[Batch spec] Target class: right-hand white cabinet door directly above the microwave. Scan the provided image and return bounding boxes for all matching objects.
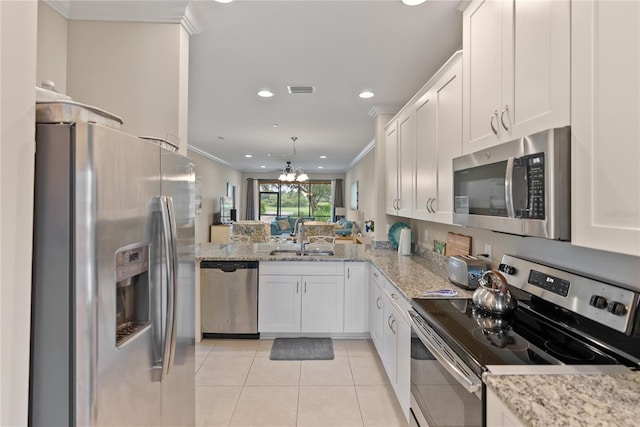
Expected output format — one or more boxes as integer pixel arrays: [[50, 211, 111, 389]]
[[510, 0, 571, 140]]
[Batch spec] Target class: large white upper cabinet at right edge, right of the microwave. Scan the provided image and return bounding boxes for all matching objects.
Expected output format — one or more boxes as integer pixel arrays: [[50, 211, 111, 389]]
[[571, 1, 640, 256]]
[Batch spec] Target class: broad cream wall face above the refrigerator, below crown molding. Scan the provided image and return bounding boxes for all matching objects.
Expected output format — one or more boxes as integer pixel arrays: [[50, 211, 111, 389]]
[[67, 21, 189, 155]]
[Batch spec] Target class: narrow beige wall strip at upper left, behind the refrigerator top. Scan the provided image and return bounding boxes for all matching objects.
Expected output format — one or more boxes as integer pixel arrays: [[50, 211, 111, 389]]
[[35, 1, 67, 93]]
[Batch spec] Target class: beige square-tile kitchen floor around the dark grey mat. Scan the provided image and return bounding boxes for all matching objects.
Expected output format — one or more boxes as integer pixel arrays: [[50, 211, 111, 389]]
[[196, 339, 407, 427]]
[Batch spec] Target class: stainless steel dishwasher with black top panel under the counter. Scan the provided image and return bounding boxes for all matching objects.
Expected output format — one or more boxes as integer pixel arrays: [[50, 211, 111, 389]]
[[200, 261, 260, 338]]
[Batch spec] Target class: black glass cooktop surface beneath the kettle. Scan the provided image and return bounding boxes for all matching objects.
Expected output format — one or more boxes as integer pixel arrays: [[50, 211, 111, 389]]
[[412, 299, 619, 367]]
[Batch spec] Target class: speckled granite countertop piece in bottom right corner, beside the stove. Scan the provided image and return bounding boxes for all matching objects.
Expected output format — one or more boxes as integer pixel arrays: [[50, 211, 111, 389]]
[[484, 371, 640, 427]]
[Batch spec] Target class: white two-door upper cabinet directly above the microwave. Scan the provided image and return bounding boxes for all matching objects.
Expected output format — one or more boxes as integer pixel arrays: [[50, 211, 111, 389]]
[[462, 0, 570, 154]]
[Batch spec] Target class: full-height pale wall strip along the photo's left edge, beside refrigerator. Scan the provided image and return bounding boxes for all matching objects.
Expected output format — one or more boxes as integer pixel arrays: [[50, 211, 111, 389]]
[[0, 1, 38, 426]]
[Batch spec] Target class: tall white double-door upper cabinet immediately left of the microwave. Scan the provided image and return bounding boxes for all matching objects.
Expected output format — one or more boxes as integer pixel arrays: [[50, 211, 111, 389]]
[[412, 52, 462, 224]]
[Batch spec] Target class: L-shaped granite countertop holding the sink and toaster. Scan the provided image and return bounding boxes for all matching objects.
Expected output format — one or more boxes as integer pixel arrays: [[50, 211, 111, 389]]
[[196, 243, 473, 299]]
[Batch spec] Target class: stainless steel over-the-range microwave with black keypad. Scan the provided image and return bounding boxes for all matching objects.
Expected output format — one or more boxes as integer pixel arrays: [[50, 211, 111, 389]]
[[453, 126, 571, 240]]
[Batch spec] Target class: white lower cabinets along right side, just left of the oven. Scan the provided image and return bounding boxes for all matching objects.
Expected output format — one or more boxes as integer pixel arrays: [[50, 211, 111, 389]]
[[369, 267, 411, 421]]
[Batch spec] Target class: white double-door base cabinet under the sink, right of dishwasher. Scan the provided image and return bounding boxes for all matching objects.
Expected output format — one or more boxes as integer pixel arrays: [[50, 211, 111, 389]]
[[258, 262, 344, 333]]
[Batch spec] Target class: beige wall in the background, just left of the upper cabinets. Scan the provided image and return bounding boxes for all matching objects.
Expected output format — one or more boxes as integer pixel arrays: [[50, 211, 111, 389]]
[[344, 147, 376, 233]]
